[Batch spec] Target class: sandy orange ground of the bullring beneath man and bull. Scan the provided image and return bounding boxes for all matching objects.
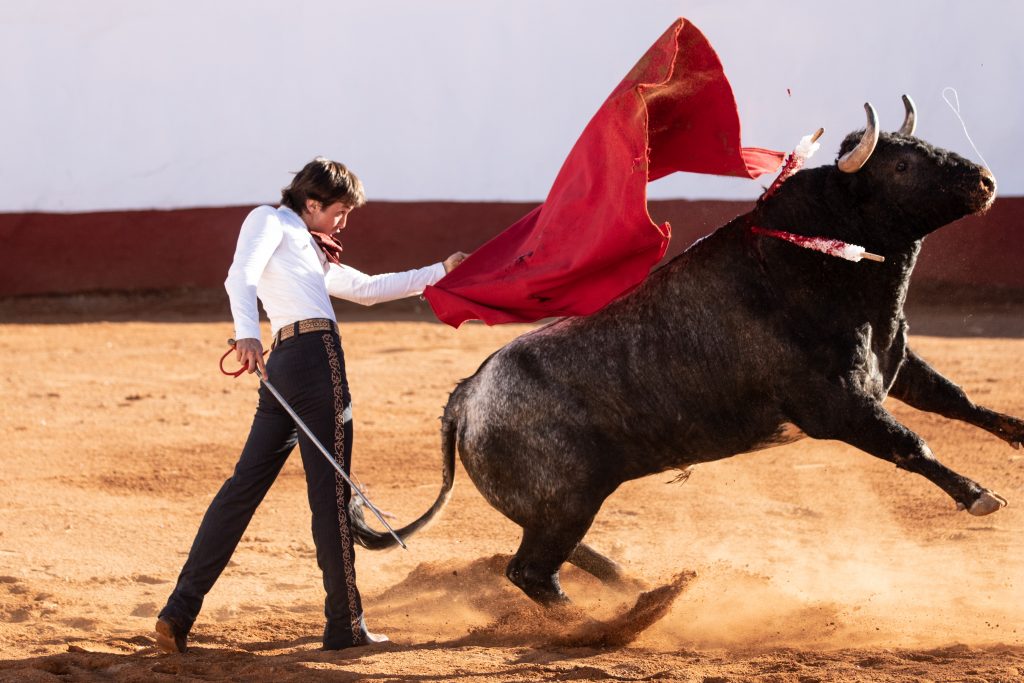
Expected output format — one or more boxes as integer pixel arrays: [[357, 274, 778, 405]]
[[0, 301, 1024, 683]]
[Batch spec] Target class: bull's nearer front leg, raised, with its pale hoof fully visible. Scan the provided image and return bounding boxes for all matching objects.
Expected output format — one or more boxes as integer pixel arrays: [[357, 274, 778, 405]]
[[790, 393, 1007, 516]]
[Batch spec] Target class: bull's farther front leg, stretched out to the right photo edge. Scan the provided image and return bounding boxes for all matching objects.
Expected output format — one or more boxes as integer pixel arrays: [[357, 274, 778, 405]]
[[889, 349, 1024, 449]]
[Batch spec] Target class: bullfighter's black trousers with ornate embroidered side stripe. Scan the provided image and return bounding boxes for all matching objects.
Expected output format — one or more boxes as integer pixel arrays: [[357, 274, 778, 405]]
[[160, 332, 366, 648]]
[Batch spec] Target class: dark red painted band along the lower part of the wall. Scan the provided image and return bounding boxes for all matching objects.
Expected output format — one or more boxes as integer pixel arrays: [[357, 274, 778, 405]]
[[0, 197, 1024, 296]]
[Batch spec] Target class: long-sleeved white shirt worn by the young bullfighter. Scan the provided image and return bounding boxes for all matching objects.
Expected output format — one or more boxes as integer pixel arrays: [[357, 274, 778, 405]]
[[224, 206, 444, 339]]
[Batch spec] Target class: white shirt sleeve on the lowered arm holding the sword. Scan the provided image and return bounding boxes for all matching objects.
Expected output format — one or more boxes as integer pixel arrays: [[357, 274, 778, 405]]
[[224, 206, 284, 339]]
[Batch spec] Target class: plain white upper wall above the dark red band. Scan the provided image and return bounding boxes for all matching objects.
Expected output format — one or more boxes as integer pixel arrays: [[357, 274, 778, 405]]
[[0, 0, 1024, 212]]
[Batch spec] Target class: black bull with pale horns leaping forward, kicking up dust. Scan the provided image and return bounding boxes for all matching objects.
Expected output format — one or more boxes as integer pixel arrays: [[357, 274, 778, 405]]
[[353, 104, 1024, 603]]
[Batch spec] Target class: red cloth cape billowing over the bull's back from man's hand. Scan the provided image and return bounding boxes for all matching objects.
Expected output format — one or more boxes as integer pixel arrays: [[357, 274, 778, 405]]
[[424, 18, 783, 327]]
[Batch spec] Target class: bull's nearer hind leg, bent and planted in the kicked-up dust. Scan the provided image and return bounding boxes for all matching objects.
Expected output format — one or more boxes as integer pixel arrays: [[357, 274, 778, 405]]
[[505, 515, 594, 606]]
